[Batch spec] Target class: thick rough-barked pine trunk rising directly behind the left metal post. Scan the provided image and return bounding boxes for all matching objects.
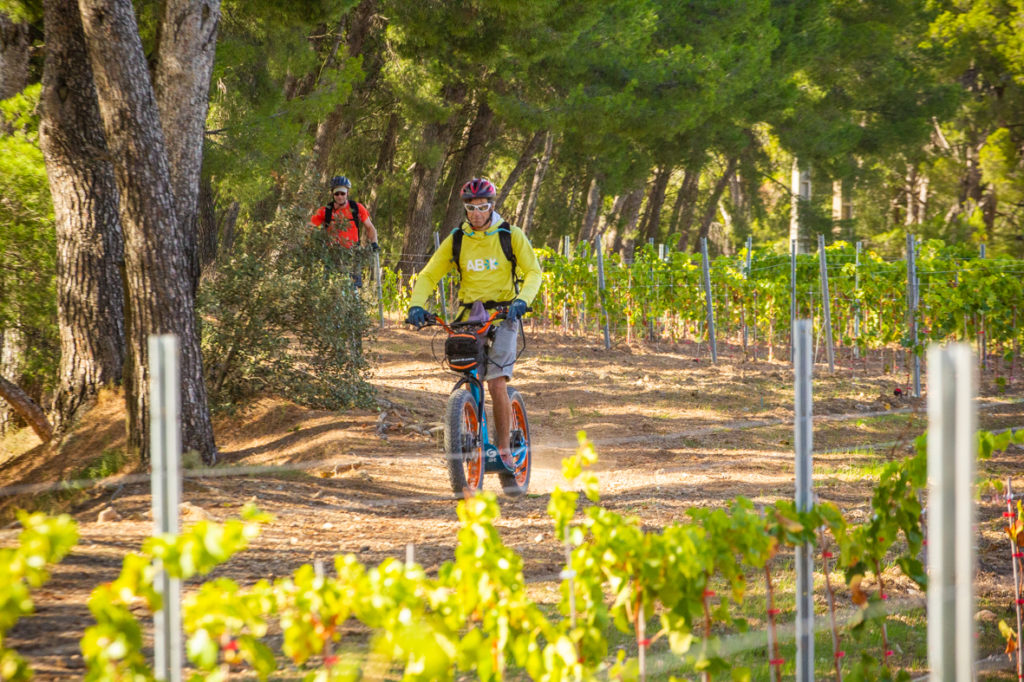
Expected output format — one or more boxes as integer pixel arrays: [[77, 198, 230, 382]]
[[79, 0, 216, 464]]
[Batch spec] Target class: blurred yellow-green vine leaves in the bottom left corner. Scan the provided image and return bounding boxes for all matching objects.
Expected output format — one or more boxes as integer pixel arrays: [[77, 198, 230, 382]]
[[0, 511, 78, 682]]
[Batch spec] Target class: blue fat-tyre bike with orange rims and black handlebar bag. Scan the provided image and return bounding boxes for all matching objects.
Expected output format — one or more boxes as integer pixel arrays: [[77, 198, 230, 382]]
[[409, 306, 532, 496]]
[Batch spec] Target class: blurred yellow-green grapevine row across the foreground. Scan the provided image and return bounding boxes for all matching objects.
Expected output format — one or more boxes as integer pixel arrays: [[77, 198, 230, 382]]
[[0, 432, 1024, 680]]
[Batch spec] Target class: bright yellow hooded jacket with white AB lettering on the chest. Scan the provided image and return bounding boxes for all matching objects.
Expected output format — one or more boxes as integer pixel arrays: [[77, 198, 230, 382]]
[[410, 213, 542, 315]]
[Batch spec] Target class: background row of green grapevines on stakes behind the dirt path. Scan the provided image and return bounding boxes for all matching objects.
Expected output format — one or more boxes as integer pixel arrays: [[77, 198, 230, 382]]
[[385, 240, 1024, 353]]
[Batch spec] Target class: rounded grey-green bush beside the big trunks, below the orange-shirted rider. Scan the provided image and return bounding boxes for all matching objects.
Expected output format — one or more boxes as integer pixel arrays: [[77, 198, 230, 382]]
[[198, 206, 372, 410]]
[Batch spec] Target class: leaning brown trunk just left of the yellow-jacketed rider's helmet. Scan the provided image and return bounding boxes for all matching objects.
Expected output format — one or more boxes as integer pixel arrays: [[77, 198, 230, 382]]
[[399, 84, 466, 275]]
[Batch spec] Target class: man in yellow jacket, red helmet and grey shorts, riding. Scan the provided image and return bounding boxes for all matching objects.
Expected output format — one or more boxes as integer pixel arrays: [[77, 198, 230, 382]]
[[406, 178, 542, 457]]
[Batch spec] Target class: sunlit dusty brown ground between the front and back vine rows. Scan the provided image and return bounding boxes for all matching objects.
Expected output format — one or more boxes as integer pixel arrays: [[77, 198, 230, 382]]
[[0, 329, 1024, 679]]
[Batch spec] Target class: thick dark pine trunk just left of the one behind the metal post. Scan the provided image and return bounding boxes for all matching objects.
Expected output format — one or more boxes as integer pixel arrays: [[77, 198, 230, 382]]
[[39, 0, 125, 433]]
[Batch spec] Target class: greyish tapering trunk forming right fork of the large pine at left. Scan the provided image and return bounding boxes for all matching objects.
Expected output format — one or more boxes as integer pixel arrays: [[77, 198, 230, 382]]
[[154, 0, 220, 297]]
